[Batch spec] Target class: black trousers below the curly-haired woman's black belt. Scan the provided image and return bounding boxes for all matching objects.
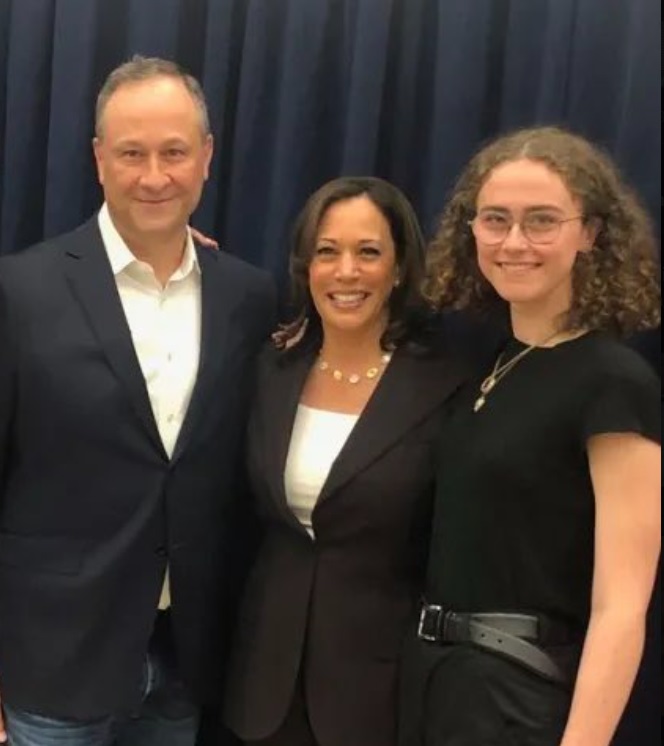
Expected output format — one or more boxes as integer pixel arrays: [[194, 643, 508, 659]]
[[399, 640, 571, 746]]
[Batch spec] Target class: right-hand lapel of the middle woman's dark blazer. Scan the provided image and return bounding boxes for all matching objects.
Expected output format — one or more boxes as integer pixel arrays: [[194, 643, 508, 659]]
[[318, 351, 465, 504]]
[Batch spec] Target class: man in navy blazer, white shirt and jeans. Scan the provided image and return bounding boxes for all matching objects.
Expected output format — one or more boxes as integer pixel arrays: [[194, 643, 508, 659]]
[[0, 58, 273, 746]]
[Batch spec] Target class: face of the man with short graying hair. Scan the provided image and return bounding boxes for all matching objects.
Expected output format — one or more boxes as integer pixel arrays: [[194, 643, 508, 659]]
[[94, 77, 212, 248]]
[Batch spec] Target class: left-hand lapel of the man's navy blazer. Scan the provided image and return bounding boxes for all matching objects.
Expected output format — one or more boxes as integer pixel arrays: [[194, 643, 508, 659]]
[[65, 217, 166, 457]]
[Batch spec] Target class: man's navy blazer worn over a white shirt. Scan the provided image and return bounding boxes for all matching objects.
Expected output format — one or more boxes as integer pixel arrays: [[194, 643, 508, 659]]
[[0, 219, 273, 718]]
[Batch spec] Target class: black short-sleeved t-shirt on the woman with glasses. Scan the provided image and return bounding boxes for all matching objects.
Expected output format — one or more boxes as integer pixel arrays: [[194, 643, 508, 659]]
[[426, 332, 661, 628]]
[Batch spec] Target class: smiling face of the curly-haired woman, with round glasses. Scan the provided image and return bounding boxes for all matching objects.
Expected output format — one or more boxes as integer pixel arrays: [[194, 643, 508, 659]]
[[473, 158, 595, 317]]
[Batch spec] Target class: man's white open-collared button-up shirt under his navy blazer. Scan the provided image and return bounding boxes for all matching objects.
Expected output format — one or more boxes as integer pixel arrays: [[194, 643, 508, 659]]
[[99, 204, 201, 609]]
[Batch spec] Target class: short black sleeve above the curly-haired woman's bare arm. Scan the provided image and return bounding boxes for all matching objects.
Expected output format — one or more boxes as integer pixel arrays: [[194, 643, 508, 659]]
[[581, 361, 662, 443]]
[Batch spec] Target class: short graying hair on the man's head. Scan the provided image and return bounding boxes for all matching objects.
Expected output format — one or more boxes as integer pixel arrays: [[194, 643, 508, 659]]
[[95, 55, 210, 137]]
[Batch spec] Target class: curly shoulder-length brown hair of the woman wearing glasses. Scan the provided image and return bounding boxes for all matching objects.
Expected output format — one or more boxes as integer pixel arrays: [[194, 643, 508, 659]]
[[424, 127, 661, 334]]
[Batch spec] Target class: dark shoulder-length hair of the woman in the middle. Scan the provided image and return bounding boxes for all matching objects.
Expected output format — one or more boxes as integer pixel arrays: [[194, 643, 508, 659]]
[[275, 176, 426, 349]]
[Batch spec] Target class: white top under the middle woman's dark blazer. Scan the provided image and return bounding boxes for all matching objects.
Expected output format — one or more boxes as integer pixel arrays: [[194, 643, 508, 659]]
[[284, 404, 359, 537]]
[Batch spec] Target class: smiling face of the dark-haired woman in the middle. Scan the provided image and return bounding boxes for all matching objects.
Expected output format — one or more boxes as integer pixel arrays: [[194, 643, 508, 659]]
[[309, 195, 397, 339]]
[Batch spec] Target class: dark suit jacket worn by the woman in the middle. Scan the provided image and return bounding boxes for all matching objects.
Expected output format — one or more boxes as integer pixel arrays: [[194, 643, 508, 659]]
[[226, 342, 462, 746]]
